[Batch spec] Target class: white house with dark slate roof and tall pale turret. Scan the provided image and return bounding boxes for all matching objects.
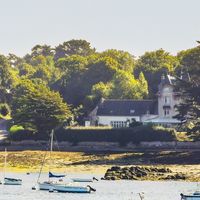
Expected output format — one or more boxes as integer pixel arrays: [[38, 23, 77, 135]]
[[85, 75, 181, 128]]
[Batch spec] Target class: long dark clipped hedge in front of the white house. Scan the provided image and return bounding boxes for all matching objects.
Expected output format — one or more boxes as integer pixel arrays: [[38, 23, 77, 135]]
[[11, 125, 175, 145]]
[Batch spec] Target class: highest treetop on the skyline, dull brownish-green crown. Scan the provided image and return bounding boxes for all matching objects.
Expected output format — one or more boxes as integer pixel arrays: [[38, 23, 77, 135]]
[[54, 40, 95, 61]]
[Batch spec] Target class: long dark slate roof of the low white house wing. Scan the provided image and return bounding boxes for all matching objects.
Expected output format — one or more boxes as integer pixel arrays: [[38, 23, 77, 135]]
[[97, 99, 158, 116]]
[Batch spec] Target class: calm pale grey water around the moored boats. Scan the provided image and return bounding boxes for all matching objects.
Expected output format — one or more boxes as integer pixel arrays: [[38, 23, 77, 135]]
[[0, 173, 200, 200]]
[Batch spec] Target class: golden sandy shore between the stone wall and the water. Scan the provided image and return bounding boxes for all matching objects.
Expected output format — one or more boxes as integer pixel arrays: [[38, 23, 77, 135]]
[[0, 151, 200, 181]]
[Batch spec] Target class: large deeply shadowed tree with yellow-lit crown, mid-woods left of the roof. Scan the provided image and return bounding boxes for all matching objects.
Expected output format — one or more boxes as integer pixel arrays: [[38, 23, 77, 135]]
[[58, 55, 117, 107]]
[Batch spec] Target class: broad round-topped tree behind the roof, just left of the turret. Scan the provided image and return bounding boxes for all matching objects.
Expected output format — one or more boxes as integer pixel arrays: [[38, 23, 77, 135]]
[[134, 49, 178, 97]]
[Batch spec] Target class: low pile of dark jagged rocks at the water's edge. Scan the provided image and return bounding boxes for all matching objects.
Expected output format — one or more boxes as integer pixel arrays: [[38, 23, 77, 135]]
[[103, 166, 188, 180]]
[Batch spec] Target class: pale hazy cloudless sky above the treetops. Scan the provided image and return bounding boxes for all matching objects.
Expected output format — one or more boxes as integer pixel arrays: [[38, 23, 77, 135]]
[[0, 0, 200, 56]]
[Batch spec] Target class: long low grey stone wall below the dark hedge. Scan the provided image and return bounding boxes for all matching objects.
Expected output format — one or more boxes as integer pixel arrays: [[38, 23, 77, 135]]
[[0, 140, 200, 151]]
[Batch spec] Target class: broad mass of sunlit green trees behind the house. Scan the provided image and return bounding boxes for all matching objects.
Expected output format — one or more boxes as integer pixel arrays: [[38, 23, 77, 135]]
[[0, 40, 200, 138]]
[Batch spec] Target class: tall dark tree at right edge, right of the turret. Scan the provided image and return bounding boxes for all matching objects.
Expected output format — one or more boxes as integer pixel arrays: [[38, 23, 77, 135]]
[[176, 46, 200, 140]]
